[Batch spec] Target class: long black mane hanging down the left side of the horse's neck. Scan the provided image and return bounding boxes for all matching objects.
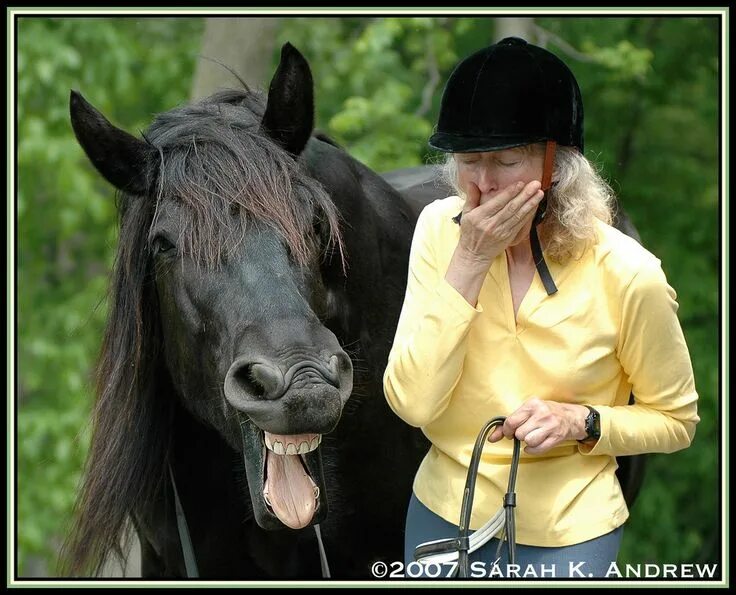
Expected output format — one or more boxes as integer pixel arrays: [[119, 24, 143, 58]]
[[59, 191, 173, 576]]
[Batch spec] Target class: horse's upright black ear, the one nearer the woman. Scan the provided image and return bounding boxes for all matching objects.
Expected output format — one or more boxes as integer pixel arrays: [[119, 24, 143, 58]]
[[261, 42, 314, 157]]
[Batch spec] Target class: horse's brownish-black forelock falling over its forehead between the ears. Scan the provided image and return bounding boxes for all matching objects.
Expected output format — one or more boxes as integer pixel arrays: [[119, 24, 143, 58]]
[[146, 91, 342, 266]]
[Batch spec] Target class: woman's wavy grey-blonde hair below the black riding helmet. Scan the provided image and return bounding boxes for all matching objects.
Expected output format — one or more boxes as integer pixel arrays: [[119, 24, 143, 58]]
[[440, 144, 616, 264]]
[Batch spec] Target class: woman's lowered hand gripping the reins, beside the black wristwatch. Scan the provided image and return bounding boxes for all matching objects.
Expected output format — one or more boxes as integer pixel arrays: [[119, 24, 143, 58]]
[[488, 397, 588, 454]]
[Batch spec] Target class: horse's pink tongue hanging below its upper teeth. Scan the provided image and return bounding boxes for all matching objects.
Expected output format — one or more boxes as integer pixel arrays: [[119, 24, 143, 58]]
[[263, 450, 317, 529]]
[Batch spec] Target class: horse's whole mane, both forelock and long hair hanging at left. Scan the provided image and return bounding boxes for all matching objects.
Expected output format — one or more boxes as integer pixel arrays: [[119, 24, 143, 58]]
[[59, 86, 342, 576]]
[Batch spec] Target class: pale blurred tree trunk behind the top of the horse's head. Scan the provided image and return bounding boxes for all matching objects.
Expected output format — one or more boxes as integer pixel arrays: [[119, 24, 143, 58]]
[[192, 17, 279, 100]]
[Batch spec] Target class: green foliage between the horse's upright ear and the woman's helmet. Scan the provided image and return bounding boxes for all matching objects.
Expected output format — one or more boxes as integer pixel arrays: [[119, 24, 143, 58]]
[[278, 18, 490, 171]]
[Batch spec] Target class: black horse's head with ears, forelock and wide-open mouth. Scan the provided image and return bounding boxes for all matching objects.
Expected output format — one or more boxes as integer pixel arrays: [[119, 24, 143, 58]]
[[71, 44, 353, 528]]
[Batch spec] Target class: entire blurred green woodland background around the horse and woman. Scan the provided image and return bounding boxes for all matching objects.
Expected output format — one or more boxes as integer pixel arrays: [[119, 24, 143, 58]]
[[16, 14, 721, 577]]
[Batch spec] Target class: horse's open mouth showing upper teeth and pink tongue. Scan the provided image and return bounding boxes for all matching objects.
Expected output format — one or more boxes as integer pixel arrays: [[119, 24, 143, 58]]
[[263, 432, 322, 529]]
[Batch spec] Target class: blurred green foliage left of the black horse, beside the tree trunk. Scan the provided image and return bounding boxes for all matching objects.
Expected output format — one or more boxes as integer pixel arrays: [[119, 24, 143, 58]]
[[17, 17, 202, 576]]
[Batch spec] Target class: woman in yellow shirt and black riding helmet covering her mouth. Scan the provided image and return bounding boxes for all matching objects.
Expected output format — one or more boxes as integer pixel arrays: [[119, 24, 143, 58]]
[[384, 38, 699, 578]]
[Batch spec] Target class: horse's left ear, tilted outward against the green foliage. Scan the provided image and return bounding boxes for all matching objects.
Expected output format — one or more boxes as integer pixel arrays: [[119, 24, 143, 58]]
[[69, 90, 156, 195]]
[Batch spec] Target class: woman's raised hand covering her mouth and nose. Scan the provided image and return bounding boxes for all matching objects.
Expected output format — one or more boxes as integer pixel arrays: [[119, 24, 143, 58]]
[[457, 180, 544, 267]]
